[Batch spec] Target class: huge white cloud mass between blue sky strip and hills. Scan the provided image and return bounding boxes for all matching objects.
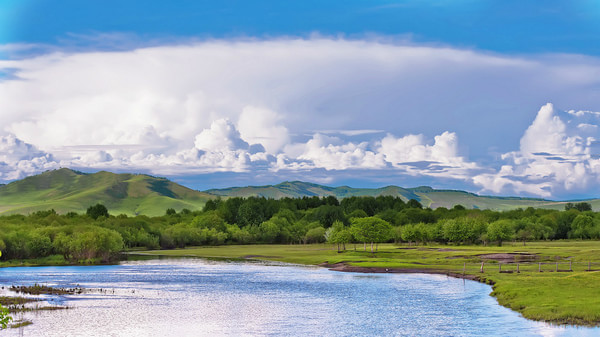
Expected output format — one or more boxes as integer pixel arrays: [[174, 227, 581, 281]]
[[0, 38, 600, 196]]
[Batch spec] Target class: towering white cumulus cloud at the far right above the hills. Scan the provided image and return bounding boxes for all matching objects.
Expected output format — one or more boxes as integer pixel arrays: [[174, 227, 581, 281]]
[[474, 103, 600, 197]]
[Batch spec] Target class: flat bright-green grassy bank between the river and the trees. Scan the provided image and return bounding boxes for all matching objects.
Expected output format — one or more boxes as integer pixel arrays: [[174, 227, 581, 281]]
[[138, 241, 600, 325]]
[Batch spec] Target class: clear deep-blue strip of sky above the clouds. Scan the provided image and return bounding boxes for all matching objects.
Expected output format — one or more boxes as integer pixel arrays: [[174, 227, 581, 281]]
[[0, 0, 600, 55]]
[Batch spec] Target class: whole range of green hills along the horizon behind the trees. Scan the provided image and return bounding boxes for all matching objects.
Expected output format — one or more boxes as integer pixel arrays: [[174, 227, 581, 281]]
[[0, 168, 600, 216]]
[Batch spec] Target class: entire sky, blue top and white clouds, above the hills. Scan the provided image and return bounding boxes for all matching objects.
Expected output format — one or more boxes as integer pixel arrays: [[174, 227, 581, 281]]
[[0, 0, 600, 200]]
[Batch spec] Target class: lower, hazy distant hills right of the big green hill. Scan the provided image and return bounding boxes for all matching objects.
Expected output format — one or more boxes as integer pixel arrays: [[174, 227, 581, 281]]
[[205, 181, 600, 210]]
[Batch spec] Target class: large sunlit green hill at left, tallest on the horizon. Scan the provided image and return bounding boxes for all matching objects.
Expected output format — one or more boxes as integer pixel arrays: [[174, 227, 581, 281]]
[[0, 168, 214, 216]]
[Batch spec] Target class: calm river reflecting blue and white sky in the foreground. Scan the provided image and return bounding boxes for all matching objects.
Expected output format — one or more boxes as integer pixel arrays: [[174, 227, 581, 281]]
[[0, 259, 600, 336]]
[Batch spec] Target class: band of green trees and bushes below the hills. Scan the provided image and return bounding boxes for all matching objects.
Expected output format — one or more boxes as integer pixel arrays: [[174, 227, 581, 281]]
[[0, 196, 600, 262]]
